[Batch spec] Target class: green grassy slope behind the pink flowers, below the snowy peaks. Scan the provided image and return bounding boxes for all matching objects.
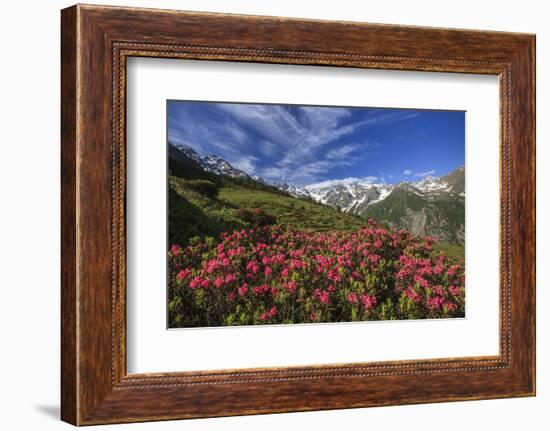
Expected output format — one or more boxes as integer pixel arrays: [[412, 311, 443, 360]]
[[168, 177, 366, 244]]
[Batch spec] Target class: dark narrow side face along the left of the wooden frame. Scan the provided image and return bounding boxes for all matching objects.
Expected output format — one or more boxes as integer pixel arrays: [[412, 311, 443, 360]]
[[60, 6, 79, 425]]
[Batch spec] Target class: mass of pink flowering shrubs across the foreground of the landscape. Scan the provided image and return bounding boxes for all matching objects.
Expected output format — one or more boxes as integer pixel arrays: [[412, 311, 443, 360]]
[[168, 221, 464, 327]]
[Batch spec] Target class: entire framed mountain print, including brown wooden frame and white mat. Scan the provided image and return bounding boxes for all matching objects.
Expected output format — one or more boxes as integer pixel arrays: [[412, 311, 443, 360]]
[[61, 5, 535, 425]]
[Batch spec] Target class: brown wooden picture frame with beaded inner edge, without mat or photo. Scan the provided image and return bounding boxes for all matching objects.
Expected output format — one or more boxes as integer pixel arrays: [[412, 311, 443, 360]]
[[61, 5, 535, 425]]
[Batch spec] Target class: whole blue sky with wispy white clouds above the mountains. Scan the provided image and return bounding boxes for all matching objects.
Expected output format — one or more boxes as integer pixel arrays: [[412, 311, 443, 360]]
[[168, 100, 465, 186]]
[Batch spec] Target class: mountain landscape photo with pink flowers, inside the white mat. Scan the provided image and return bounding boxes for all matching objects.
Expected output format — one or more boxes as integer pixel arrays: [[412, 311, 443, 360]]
[[167, 100, 466, 328]]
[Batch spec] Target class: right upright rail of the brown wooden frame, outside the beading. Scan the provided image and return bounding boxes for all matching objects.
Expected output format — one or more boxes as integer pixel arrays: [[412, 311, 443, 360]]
[[511, 35, 536, 396]]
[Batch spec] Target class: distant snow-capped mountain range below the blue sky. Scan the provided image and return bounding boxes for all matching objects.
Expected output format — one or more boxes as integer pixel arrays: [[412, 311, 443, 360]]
[[169, 145, 465, 244]]
